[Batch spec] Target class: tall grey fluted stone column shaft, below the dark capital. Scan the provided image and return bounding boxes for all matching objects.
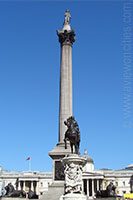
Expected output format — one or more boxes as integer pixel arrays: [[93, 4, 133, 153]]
[[59, 44, 72, 143]]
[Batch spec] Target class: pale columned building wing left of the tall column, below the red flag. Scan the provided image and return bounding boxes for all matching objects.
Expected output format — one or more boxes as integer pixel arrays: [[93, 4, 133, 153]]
[[0, 167, 52, 196]]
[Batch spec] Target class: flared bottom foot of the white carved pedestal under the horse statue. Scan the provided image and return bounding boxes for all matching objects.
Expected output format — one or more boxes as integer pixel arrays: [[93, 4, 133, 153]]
[[59, 193, 87, 200]]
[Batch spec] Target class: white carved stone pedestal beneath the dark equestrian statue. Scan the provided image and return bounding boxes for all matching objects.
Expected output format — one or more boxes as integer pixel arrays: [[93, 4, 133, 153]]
[[60, 154, 87, 200]]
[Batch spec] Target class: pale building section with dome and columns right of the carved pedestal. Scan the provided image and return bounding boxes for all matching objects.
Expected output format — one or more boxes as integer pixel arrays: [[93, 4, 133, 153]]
[[83, 151, 133, 199]]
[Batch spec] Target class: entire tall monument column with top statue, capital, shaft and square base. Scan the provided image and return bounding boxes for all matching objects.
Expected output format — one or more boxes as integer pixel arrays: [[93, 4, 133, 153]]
[[49, 10, 75, 181]]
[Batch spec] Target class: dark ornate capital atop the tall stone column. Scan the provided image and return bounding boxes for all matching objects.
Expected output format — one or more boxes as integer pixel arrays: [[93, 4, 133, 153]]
[[57, 30, 76, 46]]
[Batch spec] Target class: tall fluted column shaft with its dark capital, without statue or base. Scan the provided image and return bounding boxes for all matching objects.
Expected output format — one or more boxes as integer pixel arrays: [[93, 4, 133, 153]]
[[57, 25, 75, 144]]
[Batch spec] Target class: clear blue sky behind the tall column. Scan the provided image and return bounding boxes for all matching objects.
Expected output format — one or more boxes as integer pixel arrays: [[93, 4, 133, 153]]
[[0, 1, 133, 171]]
